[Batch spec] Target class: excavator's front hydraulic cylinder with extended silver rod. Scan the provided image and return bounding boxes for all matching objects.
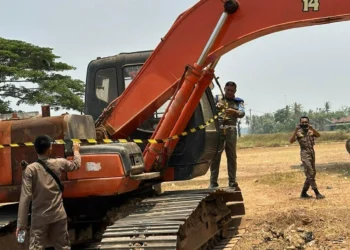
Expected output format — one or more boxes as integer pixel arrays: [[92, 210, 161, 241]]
[[144, 0, 238, 172]]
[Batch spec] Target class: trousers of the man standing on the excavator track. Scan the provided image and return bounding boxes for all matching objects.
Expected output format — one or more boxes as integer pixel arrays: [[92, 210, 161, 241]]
[[210, 128, 237, 183]]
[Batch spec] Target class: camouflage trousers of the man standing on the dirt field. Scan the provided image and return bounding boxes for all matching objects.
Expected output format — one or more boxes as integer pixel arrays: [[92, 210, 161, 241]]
[[300, 151, 317, 189]]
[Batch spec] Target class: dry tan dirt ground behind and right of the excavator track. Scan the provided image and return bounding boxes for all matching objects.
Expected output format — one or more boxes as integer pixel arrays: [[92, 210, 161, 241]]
[[165, 142, 350, 249]]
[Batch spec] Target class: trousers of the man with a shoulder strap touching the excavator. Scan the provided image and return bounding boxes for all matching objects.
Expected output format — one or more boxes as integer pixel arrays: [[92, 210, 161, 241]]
[[29, 219, 71, 250]]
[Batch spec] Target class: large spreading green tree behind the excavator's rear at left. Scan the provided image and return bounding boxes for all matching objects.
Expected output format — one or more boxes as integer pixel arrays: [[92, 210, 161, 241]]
[[0, 37, 84, 114]]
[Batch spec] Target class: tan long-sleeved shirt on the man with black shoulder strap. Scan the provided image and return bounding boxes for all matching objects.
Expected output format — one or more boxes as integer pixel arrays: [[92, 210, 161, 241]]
[[17, 152, 81, 228]]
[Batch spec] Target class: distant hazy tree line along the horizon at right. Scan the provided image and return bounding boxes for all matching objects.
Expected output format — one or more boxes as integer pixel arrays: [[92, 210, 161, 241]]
[[245, 102, 350, 134]]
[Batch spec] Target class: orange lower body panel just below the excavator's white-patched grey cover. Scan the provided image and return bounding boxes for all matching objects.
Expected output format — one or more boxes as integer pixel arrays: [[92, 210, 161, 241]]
[[63, 177, 123, 198]]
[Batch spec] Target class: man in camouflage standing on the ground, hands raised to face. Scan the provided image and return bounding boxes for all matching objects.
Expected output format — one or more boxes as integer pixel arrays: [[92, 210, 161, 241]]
[[289, 116, 325, 199]]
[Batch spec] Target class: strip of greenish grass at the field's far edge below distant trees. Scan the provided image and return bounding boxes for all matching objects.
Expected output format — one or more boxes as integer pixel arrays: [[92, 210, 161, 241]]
[[237, 131, 350, 148]]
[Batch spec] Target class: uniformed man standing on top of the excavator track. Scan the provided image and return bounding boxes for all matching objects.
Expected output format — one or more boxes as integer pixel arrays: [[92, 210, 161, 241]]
[[209, 81, 245, 188]]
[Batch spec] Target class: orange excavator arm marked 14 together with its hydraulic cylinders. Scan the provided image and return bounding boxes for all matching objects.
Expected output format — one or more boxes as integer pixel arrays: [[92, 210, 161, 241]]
[[98, 0, 350, 171]]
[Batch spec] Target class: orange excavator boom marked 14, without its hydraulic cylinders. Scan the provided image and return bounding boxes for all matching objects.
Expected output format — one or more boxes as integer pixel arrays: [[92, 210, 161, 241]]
[[102, 0, 350, 139]]
